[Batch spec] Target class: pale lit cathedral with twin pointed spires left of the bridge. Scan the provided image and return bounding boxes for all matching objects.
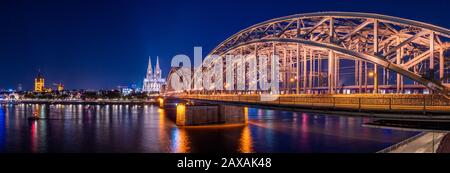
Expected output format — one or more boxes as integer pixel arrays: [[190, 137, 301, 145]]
[[142, 57, 166, 93]]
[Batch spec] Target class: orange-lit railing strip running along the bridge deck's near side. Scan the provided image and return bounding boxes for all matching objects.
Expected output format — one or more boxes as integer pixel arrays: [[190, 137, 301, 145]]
[[180, 94, 450, 112]]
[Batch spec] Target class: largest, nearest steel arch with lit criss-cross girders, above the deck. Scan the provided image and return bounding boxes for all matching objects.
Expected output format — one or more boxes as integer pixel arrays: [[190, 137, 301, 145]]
[[174, 12, 450, 97]]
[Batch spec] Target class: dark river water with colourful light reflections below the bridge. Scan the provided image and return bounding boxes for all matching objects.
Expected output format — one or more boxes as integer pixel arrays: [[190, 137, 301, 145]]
[[0, 104, 416, 153]]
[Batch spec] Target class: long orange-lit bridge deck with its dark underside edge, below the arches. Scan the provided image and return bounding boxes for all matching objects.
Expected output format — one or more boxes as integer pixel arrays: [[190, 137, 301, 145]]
[[177, 94, 450, 117]]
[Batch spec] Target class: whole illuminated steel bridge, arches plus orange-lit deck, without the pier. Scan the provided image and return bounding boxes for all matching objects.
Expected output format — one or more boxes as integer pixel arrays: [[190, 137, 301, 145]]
[[168, 12, 450, 114]]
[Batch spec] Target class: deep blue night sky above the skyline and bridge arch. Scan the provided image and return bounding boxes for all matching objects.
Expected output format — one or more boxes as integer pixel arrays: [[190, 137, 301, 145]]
[[0, 0, 450, 89]]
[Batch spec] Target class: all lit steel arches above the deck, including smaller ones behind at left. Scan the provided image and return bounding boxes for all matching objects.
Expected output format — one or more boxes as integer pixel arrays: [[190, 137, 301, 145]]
[[168, 12, 450, 98]]
